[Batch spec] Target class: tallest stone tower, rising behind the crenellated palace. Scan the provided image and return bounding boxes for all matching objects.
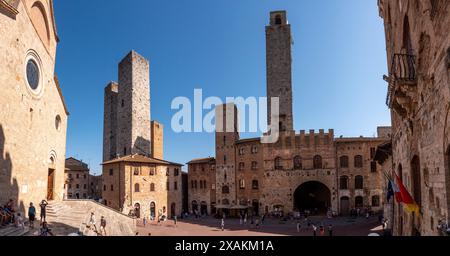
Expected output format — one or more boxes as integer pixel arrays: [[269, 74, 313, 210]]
[[266, 11, 294, 131]]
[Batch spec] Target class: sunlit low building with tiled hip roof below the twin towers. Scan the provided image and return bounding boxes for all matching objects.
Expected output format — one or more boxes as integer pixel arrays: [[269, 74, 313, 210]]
[[102, 155, 182, 218]]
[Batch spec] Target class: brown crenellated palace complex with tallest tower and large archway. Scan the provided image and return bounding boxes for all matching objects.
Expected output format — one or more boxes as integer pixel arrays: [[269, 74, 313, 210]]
[[188, 11, 391, 215]]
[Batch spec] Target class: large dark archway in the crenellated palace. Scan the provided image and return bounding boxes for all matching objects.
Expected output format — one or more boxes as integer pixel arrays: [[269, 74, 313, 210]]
[[294, 181, 331, 214]]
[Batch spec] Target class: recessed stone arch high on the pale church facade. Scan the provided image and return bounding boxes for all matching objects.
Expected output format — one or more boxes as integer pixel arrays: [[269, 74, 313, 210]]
[[30, 1, 50, 47]]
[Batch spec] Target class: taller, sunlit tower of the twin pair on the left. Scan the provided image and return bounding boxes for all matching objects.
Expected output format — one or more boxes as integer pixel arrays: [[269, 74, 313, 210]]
[[117, 51, 151, 156]]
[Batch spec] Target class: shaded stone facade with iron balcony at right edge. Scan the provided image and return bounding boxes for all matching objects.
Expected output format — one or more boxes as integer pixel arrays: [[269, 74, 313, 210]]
[[378, 0, 450, 235]]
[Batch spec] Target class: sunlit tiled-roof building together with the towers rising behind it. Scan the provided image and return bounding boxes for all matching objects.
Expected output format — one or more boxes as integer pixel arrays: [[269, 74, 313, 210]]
[[102, 51, 182, 218]]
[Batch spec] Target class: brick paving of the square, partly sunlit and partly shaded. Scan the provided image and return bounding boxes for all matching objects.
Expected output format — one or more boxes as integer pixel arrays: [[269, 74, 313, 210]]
[[137, 217, 382, 236]]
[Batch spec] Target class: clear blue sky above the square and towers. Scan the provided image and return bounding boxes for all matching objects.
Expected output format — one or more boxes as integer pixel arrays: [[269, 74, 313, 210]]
[[55, 0, 390, 173]]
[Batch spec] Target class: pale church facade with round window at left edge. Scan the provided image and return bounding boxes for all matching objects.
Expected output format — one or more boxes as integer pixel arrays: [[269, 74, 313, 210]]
[[0, 0, 68, 211]]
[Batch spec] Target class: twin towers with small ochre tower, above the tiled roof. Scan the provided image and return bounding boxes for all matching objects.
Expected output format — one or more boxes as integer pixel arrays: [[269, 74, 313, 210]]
[[103, 51, 164, 162]]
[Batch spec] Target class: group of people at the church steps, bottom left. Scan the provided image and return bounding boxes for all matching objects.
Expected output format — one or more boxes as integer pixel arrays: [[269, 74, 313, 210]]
[[0, 199, 53, 236]]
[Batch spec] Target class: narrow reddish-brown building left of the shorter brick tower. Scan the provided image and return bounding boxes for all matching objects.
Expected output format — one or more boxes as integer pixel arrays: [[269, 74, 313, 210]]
[[187, 157, 216, 215]]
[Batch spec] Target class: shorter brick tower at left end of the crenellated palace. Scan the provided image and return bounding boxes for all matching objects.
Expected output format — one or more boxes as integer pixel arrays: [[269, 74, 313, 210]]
[[216, 104, 239, 205]]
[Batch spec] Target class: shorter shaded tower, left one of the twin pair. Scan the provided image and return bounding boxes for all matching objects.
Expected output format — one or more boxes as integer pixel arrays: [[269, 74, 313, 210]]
[[103, 82, 119, 162]]
